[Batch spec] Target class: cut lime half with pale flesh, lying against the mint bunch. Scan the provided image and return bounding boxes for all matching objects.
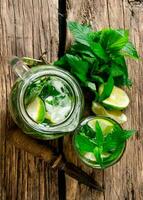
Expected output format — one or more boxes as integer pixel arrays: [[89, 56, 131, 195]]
[[99, 85, 130, 110]]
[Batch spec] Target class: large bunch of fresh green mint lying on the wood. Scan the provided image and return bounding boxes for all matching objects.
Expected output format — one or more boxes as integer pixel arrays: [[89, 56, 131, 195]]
[[54, 22, 139, 100]]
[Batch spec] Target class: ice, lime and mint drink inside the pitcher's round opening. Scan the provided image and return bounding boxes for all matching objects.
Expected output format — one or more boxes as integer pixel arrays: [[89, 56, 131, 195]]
[[24, 76, 74, 126]]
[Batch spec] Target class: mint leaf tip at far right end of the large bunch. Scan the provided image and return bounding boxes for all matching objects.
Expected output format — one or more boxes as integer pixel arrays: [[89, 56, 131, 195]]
[[121, 42, 139, 59]]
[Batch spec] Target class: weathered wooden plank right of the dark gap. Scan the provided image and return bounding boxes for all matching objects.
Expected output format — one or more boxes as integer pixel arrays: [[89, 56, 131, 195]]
[[64, 0, 143, 200]]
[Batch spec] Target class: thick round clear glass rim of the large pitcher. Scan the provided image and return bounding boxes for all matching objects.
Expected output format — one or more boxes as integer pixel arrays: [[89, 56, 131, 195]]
[[18, 65, 83, 134]]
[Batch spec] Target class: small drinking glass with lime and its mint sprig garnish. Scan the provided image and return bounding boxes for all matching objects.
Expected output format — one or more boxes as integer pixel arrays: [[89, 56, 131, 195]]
[[73, 116, 135, 169]]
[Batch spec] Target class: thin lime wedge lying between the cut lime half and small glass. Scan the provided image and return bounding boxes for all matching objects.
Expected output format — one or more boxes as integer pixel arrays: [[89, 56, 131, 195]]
[[92, 101, 127, 124]]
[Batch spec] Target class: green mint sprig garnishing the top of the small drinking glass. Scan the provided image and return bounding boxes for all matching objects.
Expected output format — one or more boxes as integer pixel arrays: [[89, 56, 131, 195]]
[[75, 121, 136, 168]]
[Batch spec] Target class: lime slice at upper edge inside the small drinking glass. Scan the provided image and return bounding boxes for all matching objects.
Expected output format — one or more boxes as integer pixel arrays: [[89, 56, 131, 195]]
[[88, 117, 115, 135]]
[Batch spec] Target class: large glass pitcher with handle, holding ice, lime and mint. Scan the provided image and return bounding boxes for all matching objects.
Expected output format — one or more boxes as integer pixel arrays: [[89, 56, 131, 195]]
[[9, 57, 84, 140]]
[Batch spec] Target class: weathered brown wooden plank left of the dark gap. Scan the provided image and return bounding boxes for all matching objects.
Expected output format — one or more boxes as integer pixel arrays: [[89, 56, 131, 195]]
[[0, 0, 59, 200]]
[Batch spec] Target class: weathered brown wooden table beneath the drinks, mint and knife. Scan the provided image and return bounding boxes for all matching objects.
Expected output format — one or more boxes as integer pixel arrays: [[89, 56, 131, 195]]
[[0, 0, 143, 200]]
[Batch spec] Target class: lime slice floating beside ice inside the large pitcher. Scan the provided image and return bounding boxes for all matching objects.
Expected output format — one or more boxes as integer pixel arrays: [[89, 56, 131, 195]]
[[26, 97, 45, 123]]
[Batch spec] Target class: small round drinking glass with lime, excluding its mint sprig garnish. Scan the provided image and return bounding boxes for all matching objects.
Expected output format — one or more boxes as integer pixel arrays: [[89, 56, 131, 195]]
[[73, 116, 126, 169]]
